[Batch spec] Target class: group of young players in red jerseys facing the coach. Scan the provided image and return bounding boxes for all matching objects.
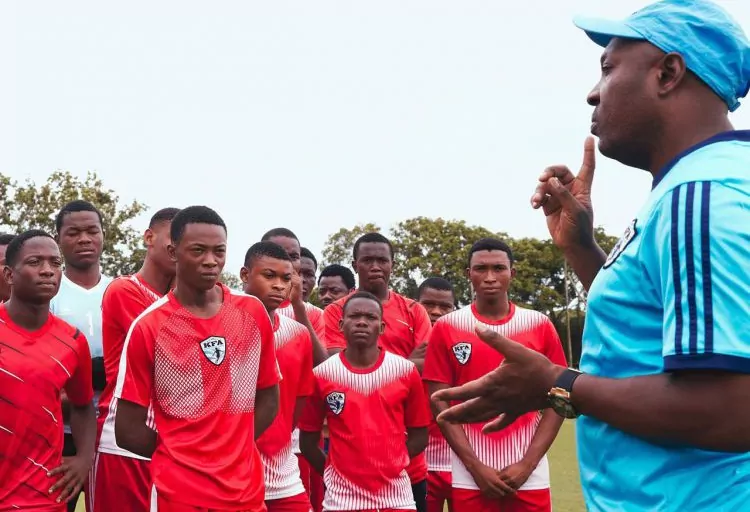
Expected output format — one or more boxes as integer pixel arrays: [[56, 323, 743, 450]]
[[0, 201, 566, 512]]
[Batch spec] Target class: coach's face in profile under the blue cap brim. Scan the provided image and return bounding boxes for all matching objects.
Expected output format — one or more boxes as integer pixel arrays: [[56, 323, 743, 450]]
[[587, 39, 659, 167]]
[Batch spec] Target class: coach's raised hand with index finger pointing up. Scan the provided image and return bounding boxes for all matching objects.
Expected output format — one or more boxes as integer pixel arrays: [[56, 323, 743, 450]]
[[531, 137, 596, 250]]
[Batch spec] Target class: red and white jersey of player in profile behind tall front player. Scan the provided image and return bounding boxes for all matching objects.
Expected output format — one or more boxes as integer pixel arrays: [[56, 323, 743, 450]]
[[97, 274, 161, 460]]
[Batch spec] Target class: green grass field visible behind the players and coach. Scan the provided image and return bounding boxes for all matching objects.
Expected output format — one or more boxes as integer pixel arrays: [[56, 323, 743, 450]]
[[76, 421, 585, 512]]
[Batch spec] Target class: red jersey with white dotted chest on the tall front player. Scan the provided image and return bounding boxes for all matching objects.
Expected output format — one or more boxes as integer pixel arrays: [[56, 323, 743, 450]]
[[115, 285, 281, 510]]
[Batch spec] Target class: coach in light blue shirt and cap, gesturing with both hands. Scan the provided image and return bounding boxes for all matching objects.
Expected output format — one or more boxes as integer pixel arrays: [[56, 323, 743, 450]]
[[439, 0, 750, 512]]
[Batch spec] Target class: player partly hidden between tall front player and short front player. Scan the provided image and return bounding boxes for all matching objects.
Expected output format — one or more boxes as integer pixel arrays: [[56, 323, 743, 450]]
[[245, 242, 313, 512]]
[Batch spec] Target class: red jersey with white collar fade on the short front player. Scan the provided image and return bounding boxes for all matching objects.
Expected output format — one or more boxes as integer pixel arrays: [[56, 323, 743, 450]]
[[300, 350, 430, 510]]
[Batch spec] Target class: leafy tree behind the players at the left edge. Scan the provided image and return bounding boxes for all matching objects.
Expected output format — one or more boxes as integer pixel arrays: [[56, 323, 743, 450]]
[[0, 171, 146, 275]]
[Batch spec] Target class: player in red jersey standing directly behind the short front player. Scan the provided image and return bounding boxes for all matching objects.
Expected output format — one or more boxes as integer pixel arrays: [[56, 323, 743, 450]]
[[323, 233, 431, 512]]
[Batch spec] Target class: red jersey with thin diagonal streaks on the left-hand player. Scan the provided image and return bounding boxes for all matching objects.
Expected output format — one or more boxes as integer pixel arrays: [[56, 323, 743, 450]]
[[0, 305, 94, 512]]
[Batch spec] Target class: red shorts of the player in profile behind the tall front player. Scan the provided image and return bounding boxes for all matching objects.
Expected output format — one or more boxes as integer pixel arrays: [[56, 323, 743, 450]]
[[86, 453, 151, 512]]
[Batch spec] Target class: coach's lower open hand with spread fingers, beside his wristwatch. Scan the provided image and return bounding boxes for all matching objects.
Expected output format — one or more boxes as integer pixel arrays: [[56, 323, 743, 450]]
[[433, 324, 565, 433]]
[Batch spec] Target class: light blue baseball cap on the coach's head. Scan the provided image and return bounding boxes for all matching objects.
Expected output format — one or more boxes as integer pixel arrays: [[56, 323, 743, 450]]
[[573, 0, 750, 112]]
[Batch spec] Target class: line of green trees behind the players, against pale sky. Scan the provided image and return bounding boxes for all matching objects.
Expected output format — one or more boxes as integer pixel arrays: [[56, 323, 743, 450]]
[[0, 171, 617, 363]]
